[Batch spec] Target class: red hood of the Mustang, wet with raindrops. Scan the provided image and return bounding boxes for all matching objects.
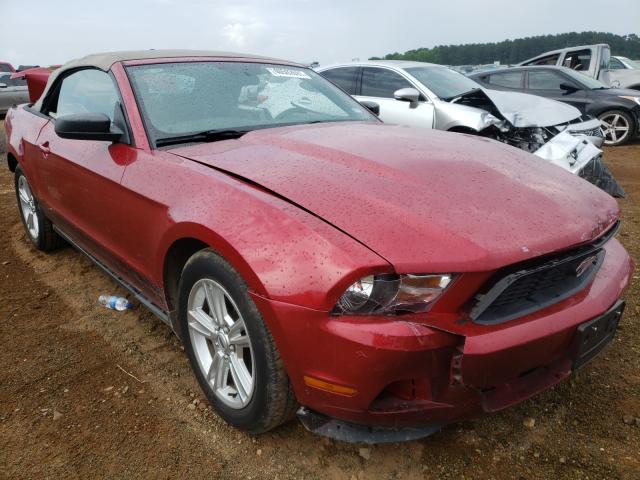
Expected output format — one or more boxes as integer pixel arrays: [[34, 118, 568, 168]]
[[169, 123, 618, 273]]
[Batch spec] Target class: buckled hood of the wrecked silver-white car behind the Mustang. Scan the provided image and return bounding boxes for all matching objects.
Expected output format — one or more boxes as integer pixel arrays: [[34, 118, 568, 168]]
[[459, 88, 581, 128]]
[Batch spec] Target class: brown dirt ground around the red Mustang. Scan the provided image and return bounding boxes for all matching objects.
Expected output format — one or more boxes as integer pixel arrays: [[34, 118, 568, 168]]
[[0, 123, 640, 480]]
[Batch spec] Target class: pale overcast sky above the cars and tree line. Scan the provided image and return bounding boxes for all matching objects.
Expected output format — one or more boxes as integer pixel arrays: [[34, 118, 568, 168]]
[[0, 0, 640, 65]]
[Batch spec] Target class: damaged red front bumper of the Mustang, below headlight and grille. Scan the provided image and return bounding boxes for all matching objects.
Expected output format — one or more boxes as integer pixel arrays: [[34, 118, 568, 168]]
[[252, 240, 633, 442]]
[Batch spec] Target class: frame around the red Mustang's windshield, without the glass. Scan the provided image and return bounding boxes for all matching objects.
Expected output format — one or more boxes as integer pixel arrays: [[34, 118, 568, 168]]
[[123, 57, 381, 149]]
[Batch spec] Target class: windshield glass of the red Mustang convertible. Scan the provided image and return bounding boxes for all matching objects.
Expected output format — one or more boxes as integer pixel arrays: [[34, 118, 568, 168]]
[[127, 61, 377, 141]]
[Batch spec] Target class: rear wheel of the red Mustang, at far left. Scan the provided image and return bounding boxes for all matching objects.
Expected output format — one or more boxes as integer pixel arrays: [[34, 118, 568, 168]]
[[15, 166, 64, 252]]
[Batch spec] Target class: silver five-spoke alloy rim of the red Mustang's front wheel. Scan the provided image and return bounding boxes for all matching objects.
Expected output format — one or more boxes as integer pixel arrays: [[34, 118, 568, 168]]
[[187, 278, 256, 409]]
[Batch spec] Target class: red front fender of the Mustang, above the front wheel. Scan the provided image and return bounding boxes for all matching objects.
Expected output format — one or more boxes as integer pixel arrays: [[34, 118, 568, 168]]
[[142, 153, 393, 311]]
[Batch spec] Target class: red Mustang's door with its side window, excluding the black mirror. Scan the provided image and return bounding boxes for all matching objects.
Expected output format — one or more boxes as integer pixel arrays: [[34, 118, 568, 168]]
[[36, 69, 138, 271]]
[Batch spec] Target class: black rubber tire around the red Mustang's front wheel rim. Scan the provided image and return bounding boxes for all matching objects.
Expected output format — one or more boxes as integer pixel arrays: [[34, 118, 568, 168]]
[[178, 249, 297, 433]]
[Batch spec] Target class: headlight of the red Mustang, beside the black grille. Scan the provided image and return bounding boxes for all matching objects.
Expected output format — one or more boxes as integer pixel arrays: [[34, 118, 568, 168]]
[[333, 274, 453, 315]]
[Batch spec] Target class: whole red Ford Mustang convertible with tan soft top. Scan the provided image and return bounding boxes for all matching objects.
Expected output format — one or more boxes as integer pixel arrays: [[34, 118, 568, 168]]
[[5, 51, 633, 441]]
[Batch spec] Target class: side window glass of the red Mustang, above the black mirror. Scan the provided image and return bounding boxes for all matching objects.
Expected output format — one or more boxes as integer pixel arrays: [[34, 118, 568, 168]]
[[49, 69, 119, 121]]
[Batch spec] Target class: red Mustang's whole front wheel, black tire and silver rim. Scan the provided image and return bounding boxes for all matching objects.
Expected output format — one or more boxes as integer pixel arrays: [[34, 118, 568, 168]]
[[179, 250, 296, 433]]
